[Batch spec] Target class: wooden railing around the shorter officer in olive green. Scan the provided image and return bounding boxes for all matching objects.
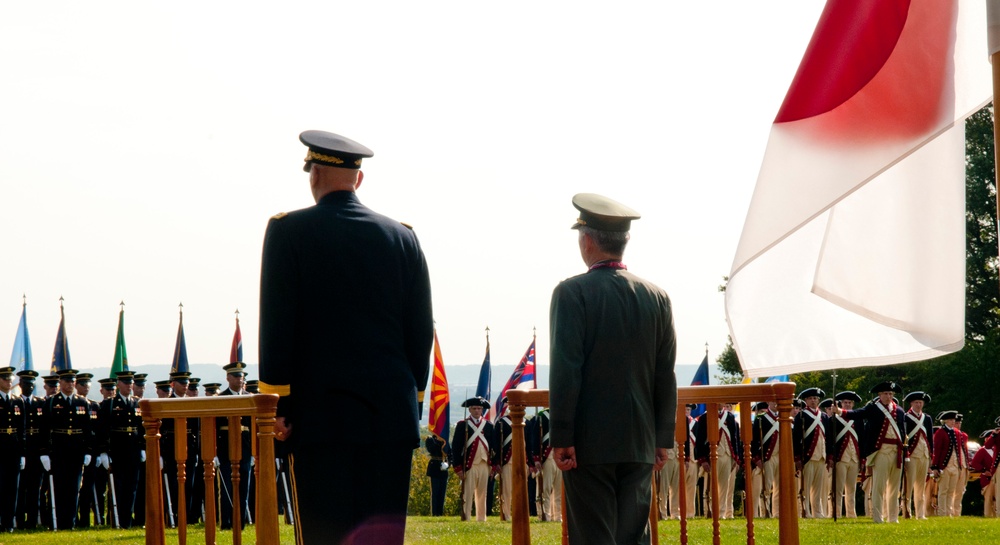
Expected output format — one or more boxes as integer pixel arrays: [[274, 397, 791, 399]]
[[507, 382, 799, 545]]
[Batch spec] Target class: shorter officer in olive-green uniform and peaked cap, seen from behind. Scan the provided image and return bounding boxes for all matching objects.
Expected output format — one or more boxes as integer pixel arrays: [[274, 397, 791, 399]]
[[549, 193, 677, 545]]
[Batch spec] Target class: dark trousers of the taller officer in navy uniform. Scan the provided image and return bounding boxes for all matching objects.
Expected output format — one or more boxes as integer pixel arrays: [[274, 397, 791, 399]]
[[288, 440, 416, 545]]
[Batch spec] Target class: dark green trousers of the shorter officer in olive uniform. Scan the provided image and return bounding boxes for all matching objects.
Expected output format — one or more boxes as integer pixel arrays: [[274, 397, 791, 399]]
[[563, 463, 653, 545]]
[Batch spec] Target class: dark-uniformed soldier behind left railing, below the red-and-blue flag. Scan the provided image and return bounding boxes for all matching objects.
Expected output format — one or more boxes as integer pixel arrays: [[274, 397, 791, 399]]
[[215, 361, 250, 530]]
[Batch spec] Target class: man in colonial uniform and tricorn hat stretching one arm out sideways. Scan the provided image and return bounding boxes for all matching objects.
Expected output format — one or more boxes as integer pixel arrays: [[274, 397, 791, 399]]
[[834, 382, 906, 523]]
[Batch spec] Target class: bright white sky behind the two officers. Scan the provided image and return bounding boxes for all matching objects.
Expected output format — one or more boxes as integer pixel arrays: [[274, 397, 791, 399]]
[[0, 0, 823, 379]]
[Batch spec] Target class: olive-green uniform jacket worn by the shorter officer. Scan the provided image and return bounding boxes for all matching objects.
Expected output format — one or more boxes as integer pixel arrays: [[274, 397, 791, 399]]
[[549, 267, 677, 465]]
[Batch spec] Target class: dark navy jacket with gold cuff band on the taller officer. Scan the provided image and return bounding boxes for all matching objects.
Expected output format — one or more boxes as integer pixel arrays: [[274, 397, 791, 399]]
[[260, 191, 433, 446]]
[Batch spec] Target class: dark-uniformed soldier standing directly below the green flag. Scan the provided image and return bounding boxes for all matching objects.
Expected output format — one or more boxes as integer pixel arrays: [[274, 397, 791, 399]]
[[96, 371, 146, 528]]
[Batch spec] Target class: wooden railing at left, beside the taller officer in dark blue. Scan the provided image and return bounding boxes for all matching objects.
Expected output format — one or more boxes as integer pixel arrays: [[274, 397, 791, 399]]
[[139, 395, 279, 545]]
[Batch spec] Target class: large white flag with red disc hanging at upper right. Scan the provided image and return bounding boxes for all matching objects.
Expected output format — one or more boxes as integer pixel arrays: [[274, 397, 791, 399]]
[[726, 0, 991, 377]]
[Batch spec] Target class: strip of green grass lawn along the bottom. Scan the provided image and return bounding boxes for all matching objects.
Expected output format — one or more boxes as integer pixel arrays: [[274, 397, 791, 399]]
[[0, 517, 1000, 545]]
